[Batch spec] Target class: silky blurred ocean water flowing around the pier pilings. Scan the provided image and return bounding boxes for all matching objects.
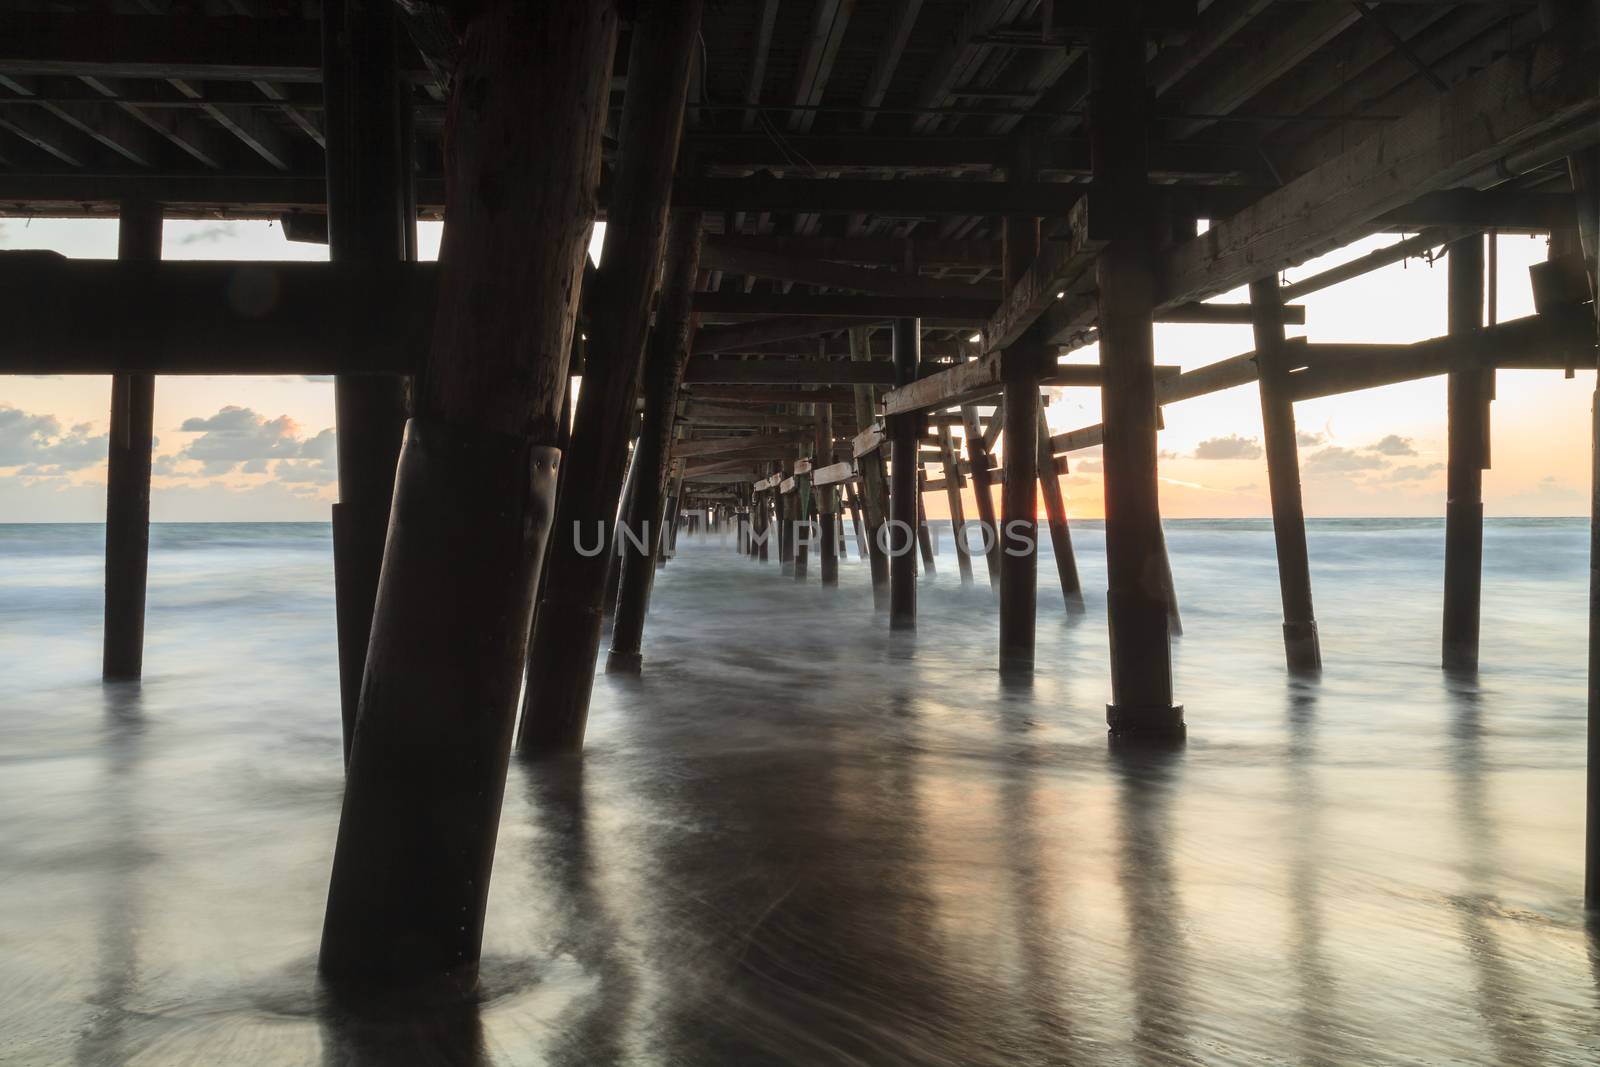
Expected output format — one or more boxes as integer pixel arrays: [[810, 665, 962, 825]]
[[0, 520, 1600, 1065]]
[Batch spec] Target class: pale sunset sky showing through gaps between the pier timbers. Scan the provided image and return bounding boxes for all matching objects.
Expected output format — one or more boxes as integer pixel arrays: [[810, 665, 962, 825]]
[[0, 219, 1594, 523]]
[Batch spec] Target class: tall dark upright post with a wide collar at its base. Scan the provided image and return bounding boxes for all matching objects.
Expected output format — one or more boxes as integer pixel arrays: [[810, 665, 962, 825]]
[[1090, 30, 1184, 737]]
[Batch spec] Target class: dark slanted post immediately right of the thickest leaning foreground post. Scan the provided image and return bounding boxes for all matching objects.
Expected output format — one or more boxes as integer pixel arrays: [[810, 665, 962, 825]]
[[518, 0, 701, 755]]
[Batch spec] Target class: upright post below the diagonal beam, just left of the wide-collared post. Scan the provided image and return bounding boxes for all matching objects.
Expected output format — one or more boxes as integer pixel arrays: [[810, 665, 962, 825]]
[[1000, 344, 1043, 675]]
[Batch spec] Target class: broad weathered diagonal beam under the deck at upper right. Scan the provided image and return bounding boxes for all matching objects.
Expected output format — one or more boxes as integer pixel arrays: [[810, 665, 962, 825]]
[[1157, 40, 1600, 313]]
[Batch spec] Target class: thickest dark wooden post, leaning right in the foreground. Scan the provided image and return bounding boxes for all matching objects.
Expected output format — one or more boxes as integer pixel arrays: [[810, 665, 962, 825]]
[[320, 0, 616, 989]]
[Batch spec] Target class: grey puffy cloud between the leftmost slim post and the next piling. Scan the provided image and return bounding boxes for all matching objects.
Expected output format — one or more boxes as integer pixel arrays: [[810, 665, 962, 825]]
[[172, 405, 338, 485]]
